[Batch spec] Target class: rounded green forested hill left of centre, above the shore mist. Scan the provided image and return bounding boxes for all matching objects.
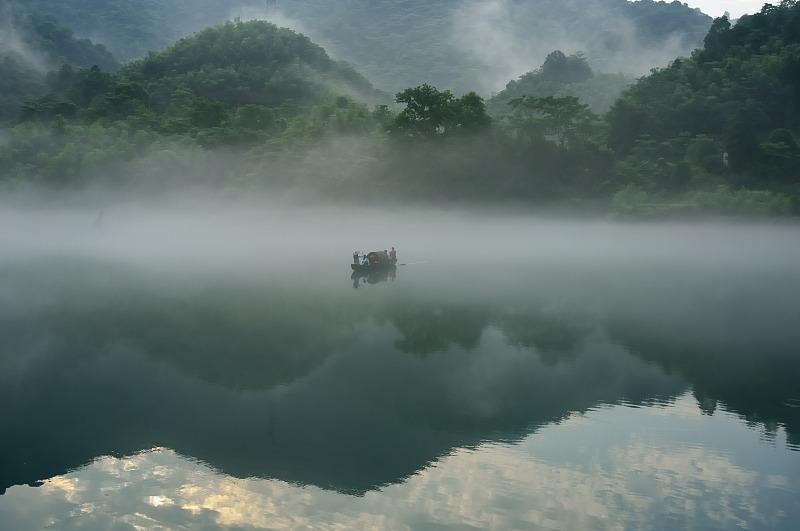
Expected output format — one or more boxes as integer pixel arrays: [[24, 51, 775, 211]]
[[22, 21, 390, 145]]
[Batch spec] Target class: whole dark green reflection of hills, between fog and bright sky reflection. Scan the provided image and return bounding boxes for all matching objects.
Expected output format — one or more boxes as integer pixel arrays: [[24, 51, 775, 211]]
[[0, 260, 800, 493]]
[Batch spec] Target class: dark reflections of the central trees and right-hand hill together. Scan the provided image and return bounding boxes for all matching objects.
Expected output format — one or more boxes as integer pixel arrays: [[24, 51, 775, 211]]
[[376, 278, 800, 445]]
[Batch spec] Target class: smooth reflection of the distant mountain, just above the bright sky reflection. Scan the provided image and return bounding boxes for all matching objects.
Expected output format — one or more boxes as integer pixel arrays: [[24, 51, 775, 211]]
[[0, 320, 682, 493]]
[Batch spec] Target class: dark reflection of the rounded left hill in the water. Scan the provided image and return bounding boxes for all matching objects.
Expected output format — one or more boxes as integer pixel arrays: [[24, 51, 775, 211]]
[[2, 264, 353, 388]]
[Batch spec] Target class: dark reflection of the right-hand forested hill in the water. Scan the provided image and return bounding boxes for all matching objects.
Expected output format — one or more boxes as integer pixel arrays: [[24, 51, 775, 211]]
[[606, 278, 800, 445]]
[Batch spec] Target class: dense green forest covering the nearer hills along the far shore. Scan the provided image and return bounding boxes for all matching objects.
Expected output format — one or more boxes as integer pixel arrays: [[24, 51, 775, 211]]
[[0, 1, 800, 216]]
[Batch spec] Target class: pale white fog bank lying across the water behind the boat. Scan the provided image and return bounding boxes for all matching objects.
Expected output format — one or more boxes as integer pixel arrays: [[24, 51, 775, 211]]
[[0, 202, 800, 271]]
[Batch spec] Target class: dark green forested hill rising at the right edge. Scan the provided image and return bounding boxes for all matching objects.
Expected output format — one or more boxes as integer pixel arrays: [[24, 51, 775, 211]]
[[608, 0, 800, 190]]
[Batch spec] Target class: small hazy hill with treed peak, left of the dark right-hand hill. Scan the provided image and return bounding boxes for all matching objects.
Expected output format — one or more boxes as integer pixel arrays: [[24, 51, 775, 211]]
[[487, 51, 634, 116]]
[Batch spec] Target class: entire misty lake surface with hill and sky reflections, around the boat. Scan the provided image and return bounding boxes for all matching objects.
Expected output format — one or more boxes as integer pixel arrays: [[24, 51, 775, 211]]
[[0, 204, 800, 531]]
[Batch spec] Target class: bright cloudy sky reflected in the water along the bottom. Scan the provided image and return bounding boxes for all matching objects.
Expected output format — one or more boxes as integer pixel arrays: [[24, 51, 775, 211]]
[[0, 394, 800, 531]]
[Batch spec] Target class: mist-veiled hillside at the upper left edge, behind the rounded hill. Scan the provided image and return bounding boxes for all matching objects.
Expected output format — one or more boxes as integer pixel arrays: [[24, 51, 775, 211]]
[[0, 8, 118, 122]]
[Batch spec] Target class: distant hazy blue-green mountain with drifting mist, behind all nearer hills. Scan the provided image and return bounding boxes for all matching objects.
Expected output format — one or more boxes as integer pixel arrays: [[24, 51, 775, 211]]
[[18, 0, 711, 95]]
